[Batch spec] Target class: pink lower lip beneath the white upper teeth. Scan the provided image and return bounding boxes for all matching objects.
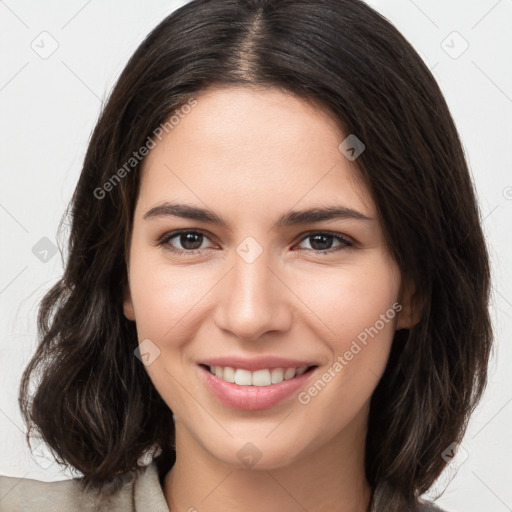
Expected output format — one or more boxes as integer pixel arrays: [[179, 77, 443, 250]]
[[199, 366, 317, 411]]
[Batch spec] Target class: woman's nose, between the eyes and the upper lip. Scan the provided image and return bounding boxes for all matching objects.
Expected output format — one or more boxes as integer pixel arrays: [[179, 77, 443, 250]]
[[215, 247, 293, 341]]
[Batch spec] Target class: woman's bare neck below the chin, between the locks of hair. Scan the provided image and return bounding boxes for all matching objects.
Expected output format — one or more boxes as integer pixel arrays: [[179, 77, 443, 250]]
[[164, 410, 371, 512]]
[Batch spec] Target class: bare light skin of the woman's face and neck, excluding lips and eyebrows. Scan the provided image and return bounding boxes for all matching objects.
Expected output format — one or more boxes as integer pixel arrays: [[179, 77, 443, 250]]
[[124, 86, 412, 512]]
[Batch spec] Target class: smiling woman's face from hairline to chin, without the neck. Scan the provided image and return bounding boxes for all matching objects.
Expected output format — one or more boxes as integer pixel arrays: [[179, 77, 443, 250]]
[[124, 87, 412, 468]]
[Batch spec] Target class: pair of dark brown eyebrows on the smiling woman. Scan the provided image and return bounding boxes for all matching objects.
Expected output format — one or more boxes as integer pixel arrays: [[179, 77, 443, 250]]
[[143, 202, 373, 227]]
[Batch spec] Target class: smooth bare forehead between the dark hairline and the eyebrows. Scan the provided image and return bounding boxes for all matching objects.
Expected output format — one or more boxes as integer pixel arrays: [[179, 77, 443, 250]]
[[139, 86, 375, 216]]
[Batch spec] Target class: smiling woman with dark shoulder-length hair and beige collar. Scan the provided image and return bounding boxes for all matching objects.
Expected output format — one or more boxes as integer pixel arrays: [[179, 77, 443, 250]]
[[0, 0, 492, 512]]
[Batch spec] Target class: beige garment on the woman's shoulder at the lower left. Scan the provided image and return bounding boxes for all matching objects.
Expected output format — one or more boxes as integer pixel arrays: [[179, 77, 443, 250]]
[[0, 464, 169, 512]]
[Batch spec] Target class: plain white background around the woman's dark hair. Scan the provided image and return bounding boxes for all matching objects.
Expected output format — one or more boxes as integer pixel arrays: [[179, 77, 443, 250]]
[[0, 0, 512, 512]]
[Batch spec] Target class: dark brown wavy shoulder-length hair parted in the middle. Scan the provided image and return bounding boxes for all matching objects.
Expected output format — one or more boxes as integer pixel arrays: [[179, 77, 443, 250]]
[[19, 0, 492, 512]]
